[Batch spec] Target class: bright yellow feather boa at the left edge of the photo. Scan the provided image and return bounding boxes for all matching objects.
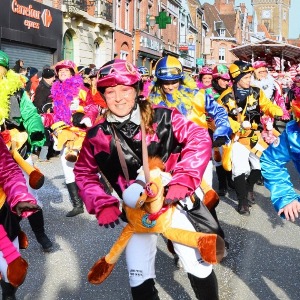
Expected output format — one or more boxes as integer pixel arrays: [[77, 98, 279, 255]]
[[0, 70, 24, 124]]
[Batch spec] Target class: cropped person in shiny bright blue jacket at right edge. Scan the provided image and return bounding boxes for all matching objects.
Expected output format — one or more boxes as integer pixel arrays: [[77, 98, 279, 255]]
[[260, 96, 300, 222]]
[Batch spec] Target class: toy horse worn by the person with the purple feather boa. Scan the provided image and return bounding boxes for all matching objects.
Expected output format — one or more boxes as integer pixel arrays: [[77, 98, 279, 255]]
[[51, 121, 86, 162]]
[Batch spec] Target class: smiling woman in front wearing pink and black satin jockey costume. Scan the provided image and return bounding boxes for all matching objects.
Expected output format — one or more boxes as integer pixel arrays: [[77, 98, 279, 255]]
[[74, 59, 219, 300]]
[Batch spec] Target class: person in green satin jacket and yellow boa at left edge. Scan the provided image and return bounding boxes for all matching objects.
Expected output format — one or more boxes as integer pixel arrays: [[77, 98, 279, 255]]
[[0, 51, 52, 251]]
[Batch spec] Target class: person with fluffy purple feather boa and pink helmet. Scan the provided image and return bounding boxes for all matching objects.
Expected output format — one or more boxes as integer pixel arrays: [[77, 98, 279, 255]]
[[51, 60, 99, 217]]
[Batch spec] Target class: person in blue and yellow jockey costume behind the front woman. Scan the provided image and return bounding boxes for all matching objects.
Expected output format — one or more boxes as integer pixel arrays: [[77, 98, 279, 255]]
[[149, 56, 232, 209]]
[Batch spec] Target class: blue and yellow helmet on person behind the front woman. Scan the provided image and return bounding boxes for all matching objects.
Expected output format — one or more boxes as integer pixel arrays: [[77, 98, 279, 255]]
[[155, 56, 183, 80]]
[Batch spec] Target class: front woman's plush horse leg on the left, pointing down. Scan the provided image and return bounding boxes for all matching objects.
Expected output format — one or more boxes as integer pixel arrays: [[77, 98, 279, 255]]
[[88, 225, 133, 284]]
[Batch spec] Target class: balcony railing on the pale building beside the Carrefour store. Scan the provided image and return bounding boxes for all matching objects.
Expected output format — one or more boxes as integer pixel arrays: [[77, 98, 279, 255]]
[[63, 0, 113, 22]]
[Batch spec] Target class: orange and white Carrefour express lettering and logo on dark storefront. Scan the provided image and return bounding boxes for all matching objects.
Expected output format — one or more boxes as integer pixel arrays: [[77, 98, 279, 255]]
[[11, 0, 52, 29]]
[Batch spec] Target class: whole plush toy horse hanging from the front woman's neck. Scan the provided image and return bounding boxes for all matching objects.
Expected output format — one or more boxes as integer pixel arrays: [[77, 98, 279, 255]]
[[88, 158, 225, 284]]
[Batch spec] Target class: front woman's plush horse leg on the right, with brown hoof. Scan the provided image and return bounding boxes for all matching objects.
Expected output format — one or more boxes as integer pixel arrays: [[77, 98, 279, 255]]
[[163, 228, 225, 264]]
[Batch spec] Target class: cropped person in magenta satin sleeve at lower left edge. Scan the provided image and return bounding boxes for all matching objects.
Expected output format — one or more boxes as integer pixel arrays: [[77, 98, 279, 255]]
[[0, 134, 40, 300]]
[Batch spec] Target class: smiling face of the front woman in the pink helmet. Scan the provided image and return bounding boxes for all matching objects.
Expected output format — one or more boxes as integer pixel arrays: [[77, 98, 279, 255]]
[[104, 85, 136, 117]]
